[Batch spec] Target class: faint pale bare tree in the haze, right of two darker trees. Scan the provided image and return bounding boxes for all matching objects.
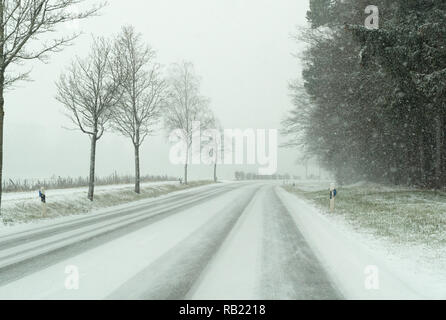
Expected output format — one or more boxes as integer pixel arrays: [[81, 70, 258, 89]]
[[164, 62, 212, 184]]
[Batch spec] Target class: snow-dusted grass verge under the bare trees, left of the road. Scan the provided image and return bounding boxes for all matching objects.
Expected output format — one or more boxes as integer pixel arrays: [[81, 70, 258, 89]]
[[2, 181, 212, 225]]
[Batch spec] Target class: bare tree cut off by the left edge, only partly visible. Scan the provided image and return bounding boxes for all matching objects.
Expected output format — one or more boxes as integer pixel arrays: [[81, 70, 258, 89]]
[[0, 0, 104, 212]]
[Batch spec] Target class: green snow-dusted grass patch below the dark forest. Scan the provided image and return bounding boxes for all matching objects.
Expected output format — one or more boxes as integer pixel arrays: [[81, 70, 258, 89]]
[[285, 183, 446, 247]]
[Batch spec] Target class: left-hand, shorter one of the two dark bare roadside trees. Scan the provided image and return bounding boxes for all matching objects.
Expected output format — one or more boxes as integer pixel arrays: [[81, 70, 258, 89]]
[[56, 38, 121, 201]]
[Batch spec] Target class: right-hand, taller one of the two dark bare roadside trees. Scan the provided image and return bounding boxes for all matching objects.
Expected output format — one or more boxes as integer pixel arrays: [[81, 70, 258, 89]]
[[113, 26, 167, 193]]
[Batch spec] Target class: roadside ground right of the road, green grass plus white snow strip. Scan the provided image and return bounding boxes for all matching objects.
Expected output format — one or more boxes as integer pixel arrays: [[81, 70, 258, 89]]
[[281, 181, 446, 299]]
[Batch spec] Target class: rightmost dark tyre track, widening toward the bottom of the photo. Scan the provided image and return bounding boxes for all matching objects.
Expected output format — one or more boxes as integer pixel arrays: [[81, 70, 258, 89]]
[[261, 186, 342, 300]]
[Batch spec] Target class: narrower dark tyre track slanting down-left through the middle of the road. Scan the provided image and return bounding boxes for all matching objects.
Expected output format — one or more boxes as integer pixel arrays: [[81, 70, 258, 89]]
[[108, 186, 260, 300]]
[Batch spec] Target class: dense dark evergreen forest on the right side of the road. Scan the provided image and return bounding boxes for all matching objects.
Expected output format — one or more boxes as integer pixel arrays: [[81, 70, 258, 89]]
[[283, 0, 446, 188]]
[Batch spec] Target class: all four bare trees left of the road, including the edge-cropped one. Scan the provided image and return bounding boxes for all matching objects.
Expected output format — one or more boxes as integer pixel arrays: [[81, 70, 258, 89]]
[[0, 0, 220, 215]]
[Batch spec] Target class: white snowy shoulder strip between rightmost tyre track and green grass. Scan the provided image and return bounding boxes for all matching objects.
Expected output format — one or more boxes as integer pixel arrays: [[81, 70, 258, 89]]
[[277, 187, 431, 299]]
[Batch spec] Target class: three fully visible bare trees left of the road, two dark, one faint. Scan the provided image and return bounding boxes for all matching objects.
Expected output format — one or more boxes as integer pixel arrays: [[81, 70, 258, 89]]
[[56, 26, 219, 201]]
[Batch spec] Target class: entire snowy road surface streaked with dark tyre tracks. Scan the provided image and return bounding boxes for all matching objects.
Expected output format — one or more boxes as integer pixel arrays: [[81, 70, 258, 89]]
[[0, 183, 402, 299]]
